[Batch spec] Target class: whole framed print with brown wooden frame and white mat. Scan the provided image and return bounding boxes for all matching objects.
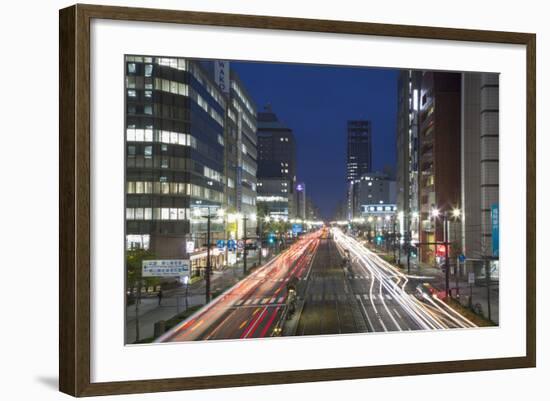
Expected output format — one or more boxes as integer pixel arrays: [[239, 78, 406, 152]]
[[59, 5, 536, 396]]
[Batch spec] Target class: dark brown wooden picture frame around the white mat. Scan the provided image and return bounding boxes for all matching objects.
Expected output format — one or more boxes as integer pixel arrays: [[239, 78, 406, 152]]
[[59, 5, 536, 396]]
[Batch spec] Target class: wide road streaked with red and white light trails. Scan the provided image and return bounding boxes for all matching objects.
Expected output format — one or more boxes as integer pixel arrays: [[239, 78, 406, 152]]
[[156, 228, 475, 342]]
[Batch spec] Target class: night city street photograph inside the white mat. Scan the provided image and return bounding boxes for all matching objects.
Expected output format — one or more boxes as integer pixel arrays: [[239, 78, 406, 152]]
[[124, 55, 500, 344]]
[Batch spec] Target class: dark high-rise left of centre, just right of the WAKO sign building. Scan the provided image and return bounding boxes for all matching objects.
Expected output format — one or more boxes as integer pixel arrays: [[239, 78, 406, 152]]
[[258, 106, 297, 219]]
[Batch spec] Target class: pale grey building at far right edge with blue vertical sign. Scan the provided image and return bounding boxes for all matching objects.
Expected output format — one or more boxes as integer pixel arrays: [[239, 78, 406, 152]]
[[461, 73, 499, 277]]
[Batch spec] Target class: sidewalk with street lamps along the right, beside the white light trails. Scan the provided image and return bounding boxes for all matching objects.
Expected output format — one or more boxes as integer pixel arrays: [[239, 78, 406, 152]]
[[370, 244, 499, 325]]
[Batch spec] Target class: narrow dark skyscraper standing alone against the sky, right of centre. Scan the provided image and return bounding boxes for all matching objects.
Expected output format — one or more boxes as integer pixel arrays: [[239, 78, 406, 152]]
[[347, 120, 372, 219]]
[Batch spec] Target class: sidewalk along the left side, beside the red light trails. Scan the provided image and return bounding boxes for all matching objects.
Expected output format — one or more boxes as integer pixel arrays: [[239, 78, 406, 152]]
[[125, 255, 273, 344]]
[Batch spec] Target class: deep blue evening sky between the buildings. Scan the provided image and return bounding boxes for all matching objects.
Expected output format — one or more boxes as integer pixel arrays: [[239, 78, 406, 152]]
[[231, 62, 399, 219]]
